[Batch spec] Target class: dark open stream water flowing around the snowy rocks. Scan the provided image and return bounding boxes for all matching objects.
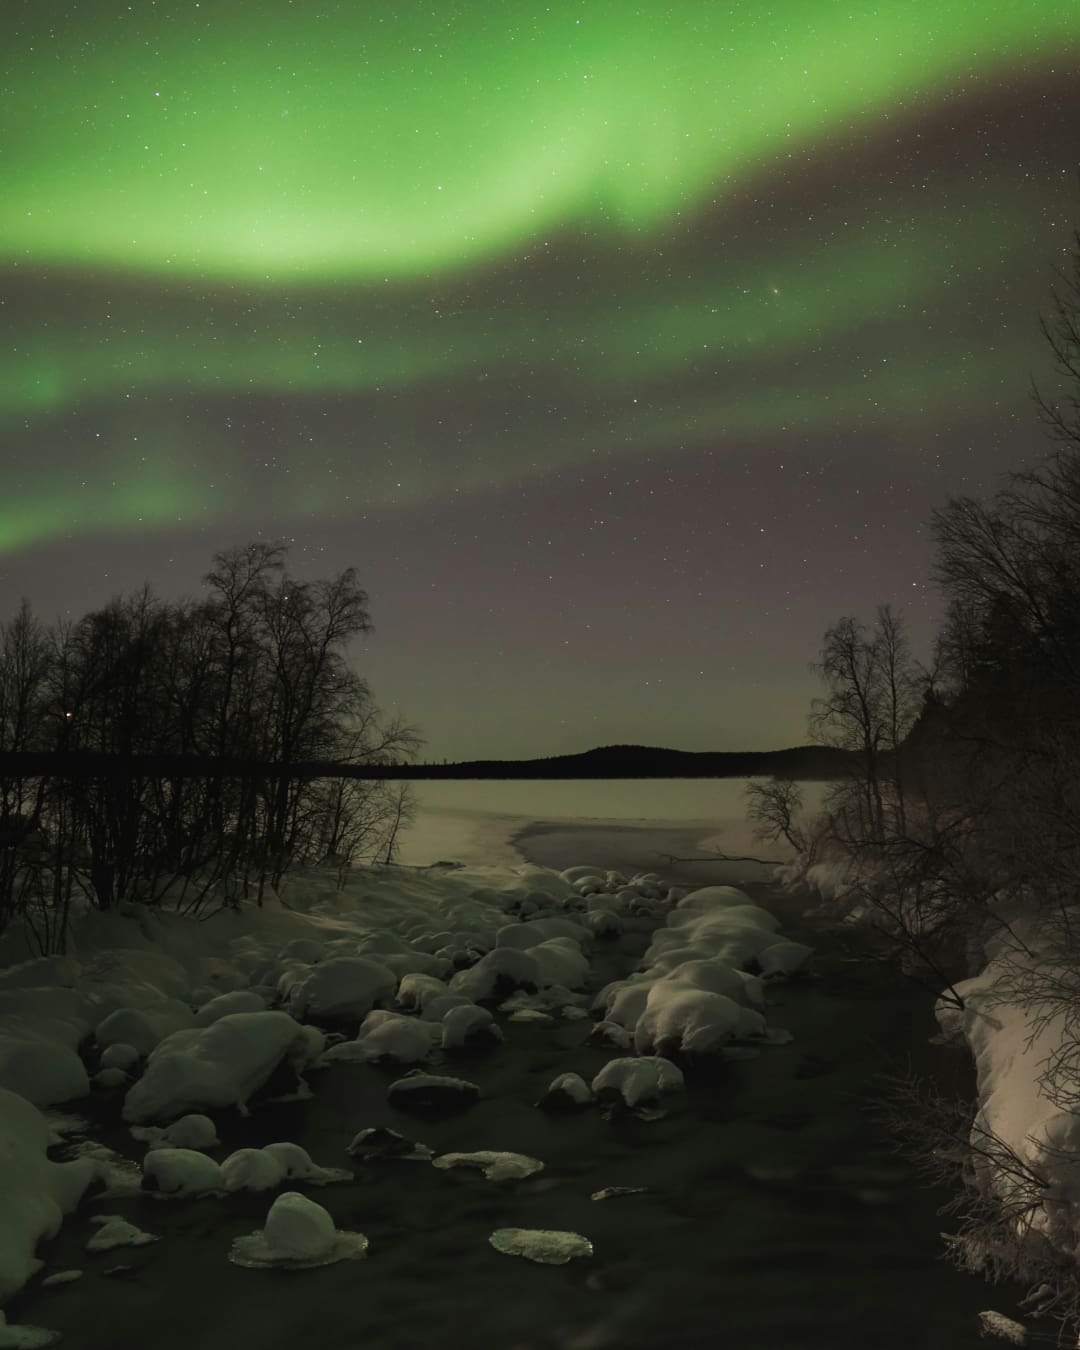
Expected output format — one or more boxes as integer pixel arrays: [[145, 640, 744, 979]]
[[8, 857, 1013, 1350]]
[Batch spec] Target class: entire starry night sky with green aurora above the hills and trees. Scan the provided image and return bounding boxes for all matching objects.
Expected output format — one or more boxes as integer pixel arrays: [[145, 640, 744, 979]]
[[0, 0, 1080, 759]]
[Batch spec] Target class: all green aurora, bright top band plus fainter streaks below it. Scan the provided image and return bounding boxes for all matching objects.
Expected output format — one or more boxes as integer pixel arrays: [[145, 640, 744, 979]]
[[0, 0, 1080, 552]]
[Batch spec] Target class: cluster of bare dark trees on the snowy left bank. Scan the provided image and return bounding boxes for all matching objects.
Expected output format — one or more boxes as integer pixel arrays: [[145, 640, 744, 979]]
[[0, 543, 420, 950]]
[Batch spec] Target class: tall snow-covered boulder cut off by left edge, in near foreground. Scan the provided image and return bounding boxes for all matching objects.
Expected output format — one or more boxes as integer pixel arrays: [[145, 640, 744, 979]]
[[0, 1088, 97, 1304]]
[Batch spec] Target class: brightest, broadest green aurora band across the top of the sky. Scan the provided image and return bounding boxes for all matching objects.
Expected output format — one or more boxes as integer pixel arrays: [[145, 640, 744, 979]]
[[0, 0, 1080, 281]]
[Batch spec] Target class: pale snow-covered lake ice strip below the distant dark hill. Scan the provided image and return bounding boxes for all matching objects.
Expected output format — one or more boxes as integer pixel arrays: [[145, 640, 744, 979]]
[[400, 778, 826, 864]]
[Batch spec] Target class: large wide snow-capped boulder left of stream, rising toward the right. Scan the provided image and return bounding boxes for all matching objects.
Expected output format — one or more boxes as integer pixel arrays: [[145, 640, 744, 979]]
[[123, 1011, 309, 1125]]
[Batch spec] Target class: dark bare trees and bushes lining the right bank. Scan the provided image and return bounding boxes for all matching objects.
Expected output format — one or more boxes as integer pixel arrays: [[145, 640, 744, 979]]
[[749, 221, 1080, 1341]]
